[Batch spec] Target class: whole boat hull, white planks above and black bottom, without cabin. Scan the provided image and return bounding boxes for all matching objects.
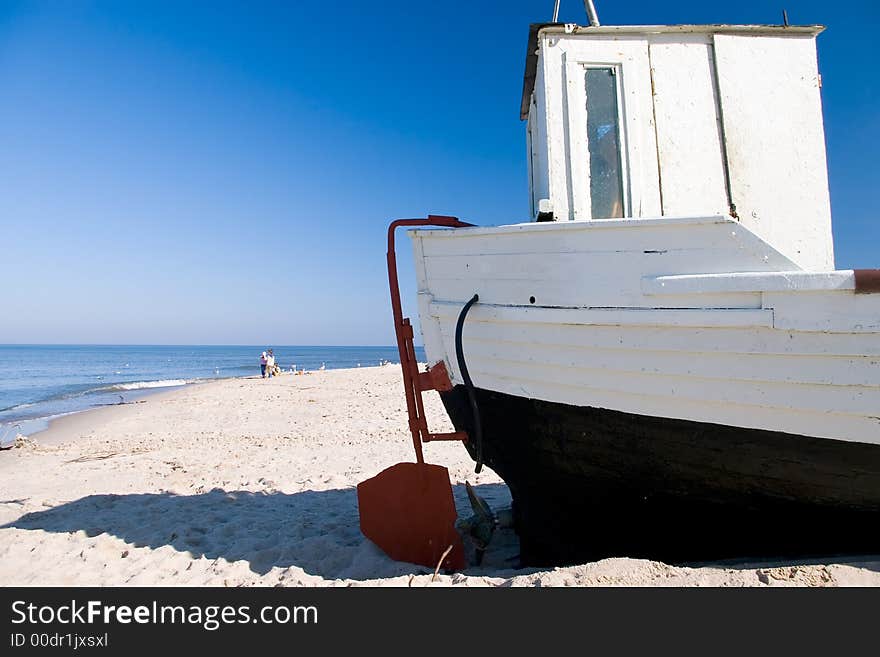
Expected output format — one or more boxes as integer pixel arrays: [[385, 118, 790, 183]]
[[412, 217, 880, 565]]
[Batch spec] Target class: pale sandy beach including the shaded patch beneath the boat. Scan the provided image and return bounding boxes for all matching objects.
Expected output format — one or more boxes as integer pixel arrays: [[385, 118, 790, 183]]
[[0, 366, 880, 586]]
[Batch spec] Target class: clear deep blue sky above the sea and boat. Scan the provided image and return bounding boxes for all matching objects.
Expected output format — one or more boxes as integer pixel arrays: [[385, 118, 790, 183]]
[[0, 0, 880, 344]]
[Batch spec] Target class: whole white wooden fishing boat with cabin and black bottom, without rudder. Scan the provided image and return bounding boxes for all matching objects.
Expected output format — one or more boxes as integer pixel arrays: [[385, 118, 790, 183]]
[[394, 3, 880, 564]]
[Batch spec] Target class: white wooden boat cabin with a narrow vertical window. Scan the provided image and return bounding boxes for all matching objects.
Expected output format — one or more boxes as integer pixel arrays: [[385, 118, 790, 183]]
[[520, 23, 834, 271]]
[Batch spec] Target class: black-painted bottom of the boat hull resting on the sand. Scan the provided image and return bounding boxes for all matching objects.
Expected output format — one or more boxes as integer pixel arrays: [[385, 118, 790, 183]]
[[441, 386, 880, 566]]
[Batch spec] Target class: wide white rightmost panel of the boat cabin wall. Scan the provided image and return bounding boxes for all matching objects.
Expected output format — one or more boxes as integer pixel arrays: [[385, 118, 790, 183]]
[[714, 34, 834, 271]]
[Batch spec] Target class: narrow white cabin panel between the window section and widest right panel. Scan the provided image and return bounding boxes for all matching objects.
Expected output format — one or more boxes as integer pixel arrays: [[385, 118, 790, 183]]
[[650, 34, 728, 216]]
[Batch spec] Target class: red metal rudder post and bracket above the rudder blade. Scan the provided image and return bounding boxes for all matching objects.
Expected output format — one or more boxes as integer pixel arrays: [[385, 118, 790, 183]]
[[388, 215, 473, 463]]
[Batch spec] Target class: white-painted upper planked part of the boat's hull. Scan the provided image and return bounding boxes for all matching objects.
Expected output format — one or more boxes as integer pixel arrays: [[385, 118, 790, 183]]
[[411, 217, 880, 444]]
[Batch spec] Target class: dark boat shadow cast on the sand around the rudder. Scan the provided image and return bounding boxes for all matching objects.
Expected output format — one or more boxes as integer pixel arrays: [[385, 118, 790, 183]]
[[0, 484, 523, 580]]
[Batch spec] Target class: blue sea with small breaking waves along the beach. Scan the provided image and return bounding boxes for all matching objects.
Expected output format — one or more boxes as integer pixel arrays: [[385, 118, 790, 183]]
[[0, 345, 425, 445]]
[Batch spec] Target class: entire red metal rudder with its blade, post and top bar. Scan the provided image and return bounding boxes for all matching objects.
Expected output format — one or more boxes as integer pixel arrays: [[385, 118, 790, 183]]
[[357, 215, 471, 570]]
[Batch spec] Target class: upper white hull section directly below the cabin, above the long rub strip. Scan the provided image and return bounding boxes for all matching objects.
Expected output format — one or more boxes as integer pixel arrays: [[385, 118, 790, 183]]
[[416, 217, 795, 308]]
